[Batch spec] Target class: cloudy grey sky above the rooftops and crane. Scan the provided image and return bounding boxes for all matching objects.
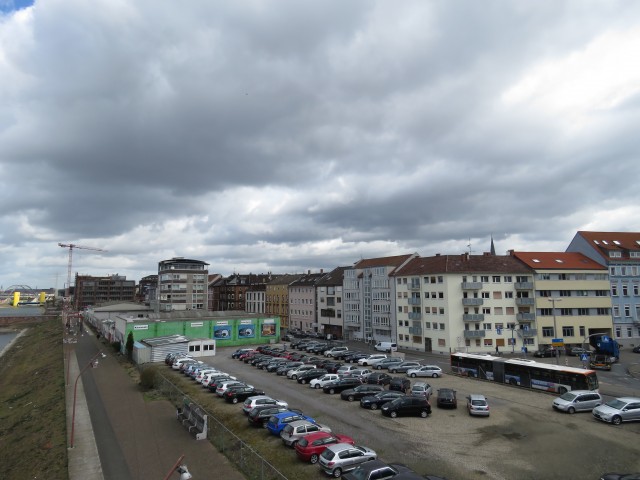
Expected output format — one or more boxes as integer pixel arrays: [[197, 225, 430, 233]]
[[0, 0, 640, 288]]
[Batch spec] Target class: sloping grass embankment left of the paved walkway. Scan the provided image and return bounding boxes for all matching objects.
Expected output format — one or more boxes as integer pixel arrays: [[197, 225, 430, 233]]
[[0, 320, 68, 480]]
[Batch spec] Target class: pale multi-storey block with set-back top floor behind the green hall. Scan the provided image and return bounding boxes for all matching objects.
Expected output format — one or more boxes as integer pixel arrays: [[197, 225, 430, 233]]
[[158, 257, 209, 312]]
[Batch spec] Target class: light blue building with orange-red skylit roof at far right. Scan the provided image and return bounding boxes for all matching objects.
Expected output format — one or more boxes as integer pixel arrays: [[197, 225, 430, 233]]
[[567, 231, 640, 346]]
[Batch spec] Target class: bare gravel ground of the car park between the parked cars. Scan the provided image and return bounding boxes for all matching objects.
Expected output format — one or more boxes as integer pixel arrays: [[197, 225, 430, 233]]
[[179, 348, 640, 480]]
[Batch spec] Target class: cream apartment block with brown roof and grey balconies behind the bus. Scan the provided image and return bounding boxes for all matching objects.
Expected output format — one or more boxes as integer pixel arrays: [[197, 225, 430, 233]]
[[392, 253, 536, 353]]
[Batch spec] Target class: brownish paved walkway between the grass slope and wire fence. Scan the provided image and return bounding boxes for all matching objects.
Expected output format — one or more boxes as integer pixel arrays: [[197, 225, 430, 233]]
[[67, 334, 245, 480]]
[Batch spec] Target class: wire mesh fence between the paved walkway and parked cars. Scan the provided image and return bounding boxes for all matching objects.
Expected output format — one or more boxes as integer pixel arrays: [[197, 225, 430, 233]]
[[155, 372, 287, 480]]
